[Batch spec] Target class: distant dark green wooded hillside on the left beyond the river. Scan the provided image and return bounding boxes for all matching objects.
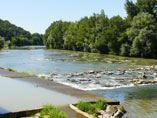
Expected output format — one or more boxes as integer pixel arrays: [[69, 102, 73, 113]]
[[0, 19, 43, 48]]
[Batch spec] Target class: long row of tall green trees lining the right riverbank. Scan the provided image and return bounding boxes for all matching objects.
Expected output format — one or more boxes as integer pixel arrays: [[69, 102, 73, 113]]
[[44, 0, 157, 58]]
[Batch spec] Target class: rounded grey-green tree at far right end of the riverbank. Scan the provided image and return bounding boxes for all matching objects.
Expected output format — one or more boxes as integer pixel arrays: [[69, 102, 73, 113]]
[[127, 13, 157, 58]]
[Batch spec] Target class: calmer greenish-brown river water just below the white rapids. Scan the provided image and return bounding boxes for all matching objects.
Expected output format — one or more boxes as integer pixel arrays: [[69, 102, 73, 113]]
[[92, 85, 157, 118]]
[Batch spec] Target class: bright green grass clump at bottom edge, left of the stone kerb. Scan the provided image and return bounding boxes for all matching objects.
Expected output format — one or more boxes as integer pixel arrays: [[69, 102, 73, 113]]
[[40, 105, 67, 118]]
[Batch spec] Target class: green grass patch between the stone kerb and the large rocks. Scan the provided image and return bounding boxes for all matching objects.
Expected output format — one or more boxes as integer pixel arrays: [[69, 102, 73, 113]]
[[76, 99, 106, 118]]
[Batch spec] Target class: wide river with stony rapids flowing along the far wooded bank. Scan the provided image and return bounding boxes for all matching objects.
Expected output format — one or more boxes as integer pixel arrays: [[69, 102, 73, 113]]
[[0, 46, 157, 118]]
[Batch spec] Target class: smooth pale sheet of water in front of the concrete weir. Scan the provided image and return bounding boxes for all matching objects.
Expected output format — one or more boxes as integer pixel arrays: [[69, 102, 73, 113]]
[[0, 76, 79, 113]]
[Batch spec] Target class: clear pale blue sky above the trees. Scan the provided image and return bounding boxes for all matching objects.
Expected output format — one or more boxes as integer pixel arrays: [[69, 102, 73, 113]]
[[0, 0, 136, 34]]
